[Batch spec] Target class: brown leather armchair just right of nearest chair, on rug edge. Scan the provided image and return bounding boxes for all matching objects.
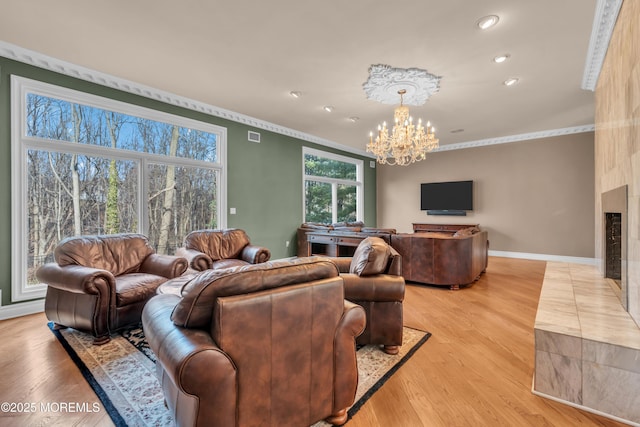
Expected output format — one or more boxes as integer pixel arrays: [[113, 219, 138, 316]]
[[329, 237, 405, 354]]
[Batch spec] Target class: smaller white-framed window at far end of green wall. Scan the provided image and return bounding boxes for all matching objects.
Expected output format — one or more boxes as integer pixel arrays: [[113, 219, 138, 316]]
[[302, 148, 363, 223]]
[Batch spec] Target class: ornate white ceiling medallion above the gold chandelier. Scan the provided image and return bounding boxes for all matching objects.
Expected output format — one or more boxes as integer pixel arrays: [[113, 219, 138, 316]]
[[362, 64, 441, 106]]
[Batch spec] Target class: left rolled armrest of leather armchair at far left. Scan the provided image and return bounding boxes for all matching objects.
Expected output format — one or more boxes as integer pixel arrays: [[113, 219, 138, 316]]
[[36, 262, 116, 298]]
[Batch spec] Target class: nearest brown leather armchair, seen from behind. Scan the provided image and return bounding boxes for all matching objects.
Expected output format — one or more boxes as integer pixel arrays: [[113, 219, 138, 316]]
[[142, 257, 366, 427]]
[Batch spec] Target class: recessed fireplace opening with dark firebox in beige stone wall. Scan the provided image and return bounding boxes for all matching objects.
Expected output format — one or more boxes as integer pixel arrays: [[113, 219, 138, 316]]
[[601, 185, 628, 310]]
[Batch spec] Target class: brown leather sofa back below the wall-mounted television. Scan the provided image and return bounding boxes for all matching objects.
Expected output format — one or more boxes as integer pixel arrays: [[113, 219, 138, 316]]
[[391, 227, 489, 289]]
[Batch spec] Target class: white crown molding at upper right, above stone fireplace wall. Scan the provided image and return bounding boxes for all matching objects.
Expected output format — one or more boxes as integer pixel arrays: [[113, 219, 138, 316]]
[[581, 0, 622, 91]]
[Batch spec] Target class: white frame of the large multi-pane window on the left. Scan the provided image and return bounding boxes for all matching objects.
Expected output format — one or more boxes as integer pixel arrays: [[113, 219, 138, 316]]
[[11, 76, 227, 302]]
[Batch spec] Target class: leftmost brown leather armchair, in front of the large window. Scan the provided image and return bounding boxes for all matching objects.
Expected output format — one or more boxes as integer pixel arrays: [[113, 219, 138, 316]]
[[36, 234, 187, 345]]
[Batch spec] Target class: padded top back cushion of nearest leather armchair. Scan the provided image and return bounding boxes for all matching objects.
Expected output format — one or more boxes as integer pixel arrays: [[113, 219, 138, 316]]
[[171, 257, 339, 329]]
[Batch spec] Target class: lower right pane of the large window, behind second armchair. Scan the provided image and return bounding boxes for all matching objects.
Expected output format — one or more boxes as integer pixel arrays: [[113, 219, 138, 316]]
[[148, 164, 218, 255]]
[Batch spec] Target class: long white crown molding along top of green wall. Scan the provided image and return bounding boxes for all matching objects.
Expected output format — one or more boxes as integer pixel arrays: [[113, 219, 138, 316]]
[[0, 40, 371, 157]]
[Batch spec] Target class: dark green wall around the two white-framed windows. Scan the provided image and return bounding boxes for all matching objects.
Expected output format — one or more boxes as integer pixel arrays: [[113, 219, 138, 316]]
[[0, 57, 376, 306]]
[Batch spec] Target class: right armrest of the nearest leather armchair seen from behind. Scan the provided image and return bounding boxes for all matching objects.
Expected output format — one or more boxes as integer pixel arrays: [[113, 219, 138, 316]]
[[333, 300, 367, 412]]
